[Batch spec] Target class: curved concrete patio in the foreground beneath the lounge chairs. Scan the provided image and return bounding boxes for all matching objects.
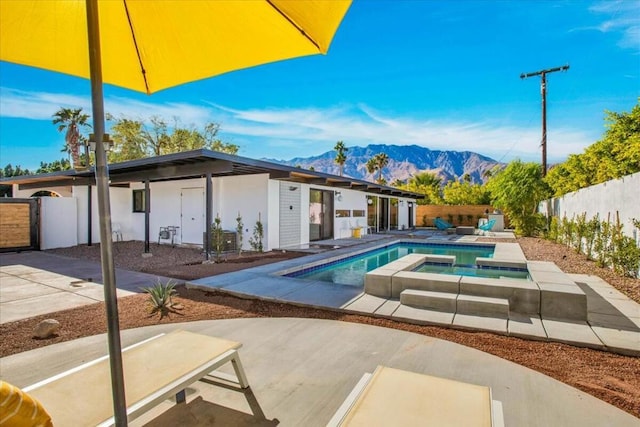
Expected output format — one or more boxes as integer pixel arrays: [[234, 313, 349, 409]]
[[0, 318, 638, 427]]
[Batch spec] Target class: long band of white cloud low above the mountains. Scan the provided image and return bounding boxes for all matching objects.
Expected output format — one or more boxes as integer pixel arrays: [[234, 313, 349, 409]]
[[0, 88, 594, 162]]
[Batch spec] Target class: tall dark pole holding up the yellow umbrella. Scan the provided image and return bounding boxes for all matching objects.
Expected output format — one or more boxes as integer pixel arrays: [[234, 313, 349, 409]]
[[86, 0, 127, 426]]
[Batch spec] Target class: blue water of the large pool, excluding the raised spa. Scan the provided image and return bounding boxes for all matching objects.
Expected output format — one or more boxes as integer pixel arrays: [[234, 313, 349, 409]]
[[287, 242, 495, 287]]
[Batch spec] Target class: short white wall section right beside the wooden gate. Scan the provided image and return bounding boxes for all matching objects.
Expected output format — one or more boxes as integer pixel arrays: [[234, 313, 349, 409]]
[[40, 197, 78, 250]]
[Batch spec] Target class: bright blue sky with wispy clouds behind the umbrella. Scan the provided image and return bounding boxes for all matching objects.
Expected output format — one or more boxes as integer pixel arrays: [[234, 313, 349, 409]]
[[0, 0, 640, 169]]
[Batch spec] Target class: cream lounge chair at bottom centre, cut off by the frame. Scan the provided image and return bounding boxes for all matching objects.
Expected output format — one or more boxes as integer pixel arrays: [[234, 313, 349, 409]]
[[327, 366, 503, 427]]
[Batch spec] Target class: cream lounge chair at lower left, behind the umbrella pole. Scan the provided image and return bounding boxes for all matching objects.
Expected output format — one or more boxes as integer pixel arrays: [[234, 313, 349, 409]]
[[24, 331, 249, 427]]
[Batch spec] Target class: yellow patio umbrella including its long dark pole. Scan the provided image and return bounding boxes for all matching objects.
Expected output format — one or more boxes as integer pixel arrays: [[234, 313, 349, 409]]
[[0, 0, 351, 425]]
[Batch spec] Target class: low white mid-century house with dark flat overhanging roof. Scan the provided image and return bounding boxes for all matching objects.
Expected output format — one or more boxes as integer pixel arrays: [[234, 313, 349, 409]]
[[0, 150, 422, 250]]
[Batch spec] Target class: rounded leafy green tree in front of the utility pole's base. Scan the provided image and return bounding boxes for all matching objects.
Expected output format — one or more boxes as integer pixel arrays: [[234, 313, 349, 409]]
[[487, 160, 551, 236]]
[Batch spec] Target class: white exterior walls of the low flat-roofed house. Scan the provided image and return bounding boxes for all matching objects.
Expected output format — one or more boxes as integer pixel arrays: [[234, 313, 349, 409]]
[[14, 174, 420, 250]]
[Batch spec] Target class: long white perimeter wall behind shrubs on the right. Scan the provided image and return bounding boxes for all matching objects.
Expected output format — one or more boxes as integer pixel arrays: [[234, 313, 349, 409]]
[[539, 172, 640, 241]]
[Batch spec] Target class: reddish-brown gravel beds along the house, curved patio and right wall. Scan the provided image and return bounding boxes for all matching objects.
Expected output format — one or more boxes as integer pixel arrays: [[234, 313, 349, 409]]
[[0, 238, 640, 417]]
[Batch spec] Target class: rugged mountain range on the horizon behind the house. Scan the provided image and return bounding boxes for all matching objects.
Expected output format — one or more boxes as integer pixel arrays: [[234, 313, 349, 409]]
[[265, 144, 501, 184]]
